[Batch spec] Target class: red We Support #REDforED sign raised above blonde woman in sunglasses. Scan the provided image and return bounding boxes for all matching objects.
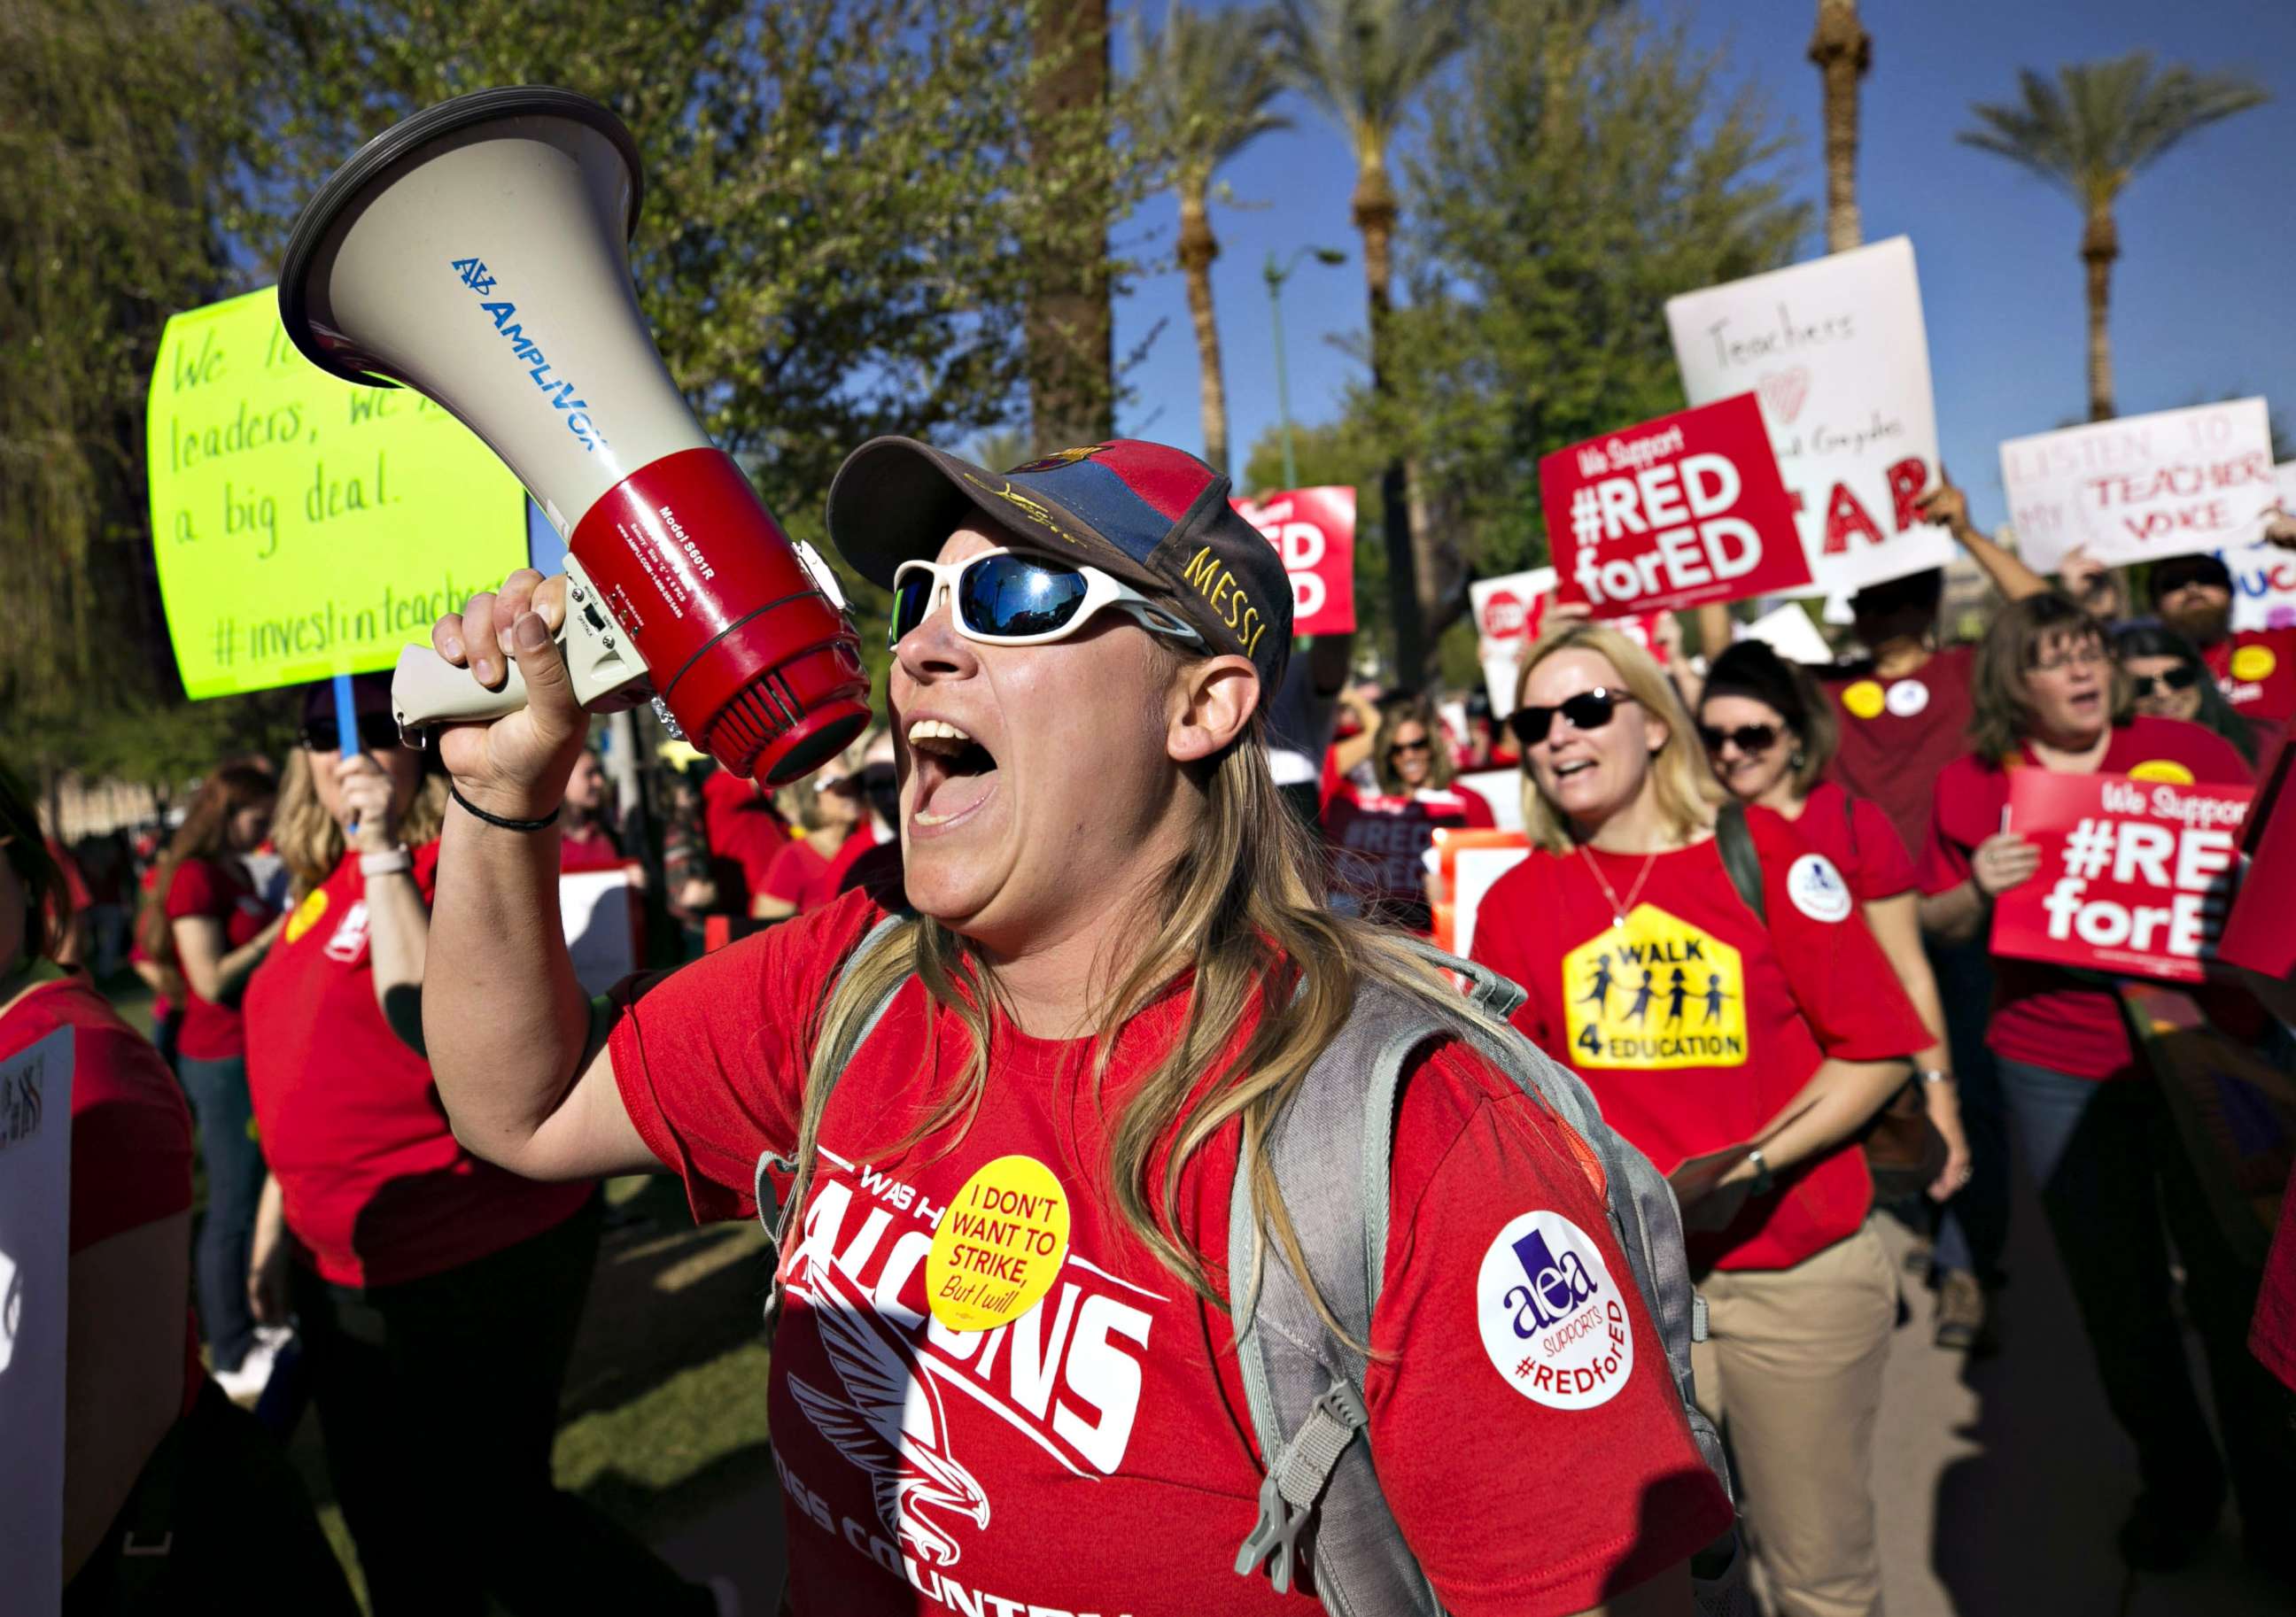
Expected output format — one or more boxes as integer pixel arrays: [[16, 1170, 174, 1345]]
[[1539, 393, 1809, 618]]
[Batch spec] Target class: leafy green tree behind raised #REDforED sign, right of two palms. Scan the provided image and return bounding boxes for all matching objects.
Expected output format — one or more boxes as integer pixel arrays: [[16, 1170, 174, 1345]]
[[1357, 0, 1811, 583]]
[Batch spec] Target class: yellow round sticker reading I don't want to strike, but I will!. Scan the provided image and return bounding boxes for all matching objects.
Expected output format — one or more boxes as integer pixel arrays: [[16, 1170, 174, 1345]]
[[926, 1156, 1067, 1330]]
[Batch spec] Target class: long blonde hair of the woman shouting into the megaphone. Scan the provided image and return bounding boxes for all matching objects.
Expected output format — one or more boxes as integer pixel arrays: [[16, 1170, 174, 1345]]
[[787, 707, 1501, 1330]]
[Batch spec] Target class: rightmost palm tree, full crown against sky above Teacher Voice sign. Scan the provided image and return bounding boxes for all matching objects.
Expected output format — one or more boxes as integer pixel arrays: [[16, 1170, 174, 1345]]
[[1961, 50, 2266, 421]]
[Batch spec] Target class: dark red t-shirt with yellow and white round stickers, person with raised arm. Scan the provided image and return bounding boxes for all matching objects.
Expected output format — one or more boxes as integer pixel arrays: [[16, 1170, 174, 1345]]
[[1811, 646, 1977, 847]]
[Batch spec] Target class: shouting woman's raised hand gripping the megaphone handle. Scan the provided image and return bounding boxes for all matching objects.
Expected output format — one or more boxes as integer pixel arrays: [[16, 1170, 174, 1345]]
[[431, 568, 590, 820]]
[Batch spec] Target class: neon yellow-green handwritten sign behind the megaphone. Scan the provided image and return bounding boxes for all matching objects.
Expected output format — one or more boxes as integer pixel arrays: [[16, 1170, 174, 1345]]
[[144, 290, 526, 696]]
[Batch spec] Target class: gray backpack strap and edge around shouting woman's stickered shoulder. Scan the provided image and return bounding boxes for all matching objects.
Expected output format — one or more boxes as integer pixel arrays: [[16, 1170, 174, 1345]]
[[1229, 944, 1749, 1617]]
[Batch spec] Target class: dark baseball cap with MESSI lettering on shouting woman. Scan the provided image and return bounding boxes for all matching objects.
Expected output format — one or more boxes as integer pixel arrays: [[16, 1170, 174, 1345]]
[[829, 438, 1292, 705]]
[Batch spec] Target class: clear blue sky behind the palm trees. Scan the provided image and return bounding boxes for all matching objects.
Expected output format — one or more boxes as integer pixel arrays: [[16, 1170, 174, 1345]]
[[1116, 0, 2296, 526]]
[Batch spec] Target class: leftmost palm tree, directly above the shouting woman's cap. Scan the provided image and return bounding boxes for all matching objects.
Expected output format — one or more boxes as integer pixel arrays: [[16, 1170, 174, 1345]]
[[1129, 0, 1291, 471]]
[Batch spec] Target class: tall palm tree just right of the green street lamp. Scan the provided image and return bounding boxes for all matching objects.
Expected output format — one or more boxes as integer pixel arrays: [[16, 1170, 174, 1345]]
[[1276, 0, 1465, 689]]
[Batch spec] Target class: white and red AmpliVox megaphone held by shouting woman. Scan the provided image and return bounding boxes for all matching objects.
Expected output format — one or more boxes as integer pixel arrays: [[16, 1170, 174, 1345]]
[[280, 85, 868, 785]]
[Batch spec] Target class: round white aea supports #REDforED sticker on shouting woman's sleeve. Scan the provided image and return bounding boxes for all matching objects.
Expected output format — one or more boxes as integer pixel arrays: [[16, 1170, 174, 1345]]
[[1474, 1213, 1635, 1411]]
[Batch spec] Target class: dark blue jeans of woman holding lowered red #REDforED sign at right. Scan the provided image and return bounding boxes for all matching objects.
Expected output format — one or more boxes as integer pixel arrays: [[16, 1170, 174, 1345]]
[[2000, 1061, 2296, 1525]]
